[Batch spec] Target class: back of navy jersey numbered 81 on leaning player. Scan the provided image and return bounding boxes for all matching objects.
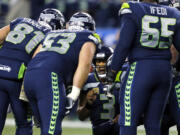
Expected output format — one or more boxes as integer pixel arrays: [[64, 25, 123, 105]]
[[0, 18, 50, 63]]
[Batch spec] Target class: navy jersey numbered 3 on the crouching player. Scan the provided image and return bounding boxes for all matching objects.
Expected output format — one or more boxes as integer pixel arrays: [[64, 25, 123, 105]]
[[82, 73, 119, 126]]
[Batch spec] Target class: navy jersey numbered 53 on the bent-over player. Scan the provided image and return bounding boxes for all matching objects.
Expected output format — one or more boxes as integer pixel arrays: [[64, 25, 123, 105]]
[[27, 30, 100, 86]]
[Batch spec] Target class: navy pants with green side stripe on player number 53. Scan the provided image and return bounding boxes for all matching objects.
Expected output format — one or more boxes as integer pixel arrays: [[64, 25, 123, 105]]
[[24, 69, 66, 135]]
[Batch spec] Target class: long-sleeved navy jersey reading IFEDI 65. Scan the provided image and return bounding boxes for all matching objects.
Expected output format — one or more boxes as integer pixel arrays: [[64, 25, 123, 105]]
[[112, 2, 180, 71]]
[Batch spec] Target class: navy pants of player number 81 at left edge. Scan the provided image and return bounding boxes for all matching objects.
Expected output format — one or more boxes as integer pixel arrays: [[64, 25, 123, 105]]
[[0, 78, 32, 135]]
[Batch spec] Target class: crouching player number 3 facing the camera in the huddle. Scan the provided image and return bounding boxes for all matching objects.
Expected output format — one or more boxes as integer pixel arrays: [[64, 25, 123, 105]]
[[77, 46, 119, 135]]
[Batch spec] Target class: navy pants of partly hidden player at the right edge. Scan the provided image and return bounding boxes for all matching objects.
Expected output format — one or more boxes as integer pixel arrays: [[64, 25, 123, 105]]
[[161, 76, 180, 135]]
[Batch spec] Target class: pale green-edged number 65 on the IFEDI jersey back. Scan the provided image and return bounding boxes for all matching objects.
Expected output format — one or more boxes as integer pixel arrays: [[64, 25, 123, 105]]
[[140, 15, 176, 49]]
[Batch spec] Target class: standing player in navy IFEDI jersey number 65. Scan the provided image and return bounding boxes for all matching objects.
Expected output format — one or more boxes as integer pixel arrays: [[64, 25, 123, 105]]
[[108, 0, 180, 135]]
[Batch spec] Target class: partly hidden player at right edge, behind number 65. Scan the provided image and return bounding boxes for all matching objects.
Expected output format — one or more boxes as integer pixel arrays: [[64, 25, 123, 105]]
[[161, 46, 180, 135]]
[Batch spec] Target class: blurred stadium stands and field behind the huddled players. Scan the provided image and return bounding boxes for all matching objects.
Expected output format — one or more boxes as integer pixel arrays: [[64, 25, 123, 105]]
[[0, 0, 177, 135]]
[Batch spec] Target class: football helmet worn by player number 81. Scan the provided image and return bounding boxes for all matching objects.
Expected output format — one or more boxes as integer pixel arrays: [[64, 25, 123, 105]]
[[38, 8, 65, 30]]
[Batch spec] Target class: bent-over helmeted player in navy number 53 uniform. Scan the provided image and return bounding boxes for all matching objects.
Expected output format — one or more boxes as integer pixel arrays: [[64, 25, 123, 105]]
[[24, 12, 100, 135]]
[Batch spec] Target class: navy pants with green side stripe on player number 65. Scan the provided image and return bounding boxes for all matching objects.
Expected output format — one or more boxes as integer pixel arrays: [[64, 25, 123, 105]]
[[119, 60, 172, 135]]
